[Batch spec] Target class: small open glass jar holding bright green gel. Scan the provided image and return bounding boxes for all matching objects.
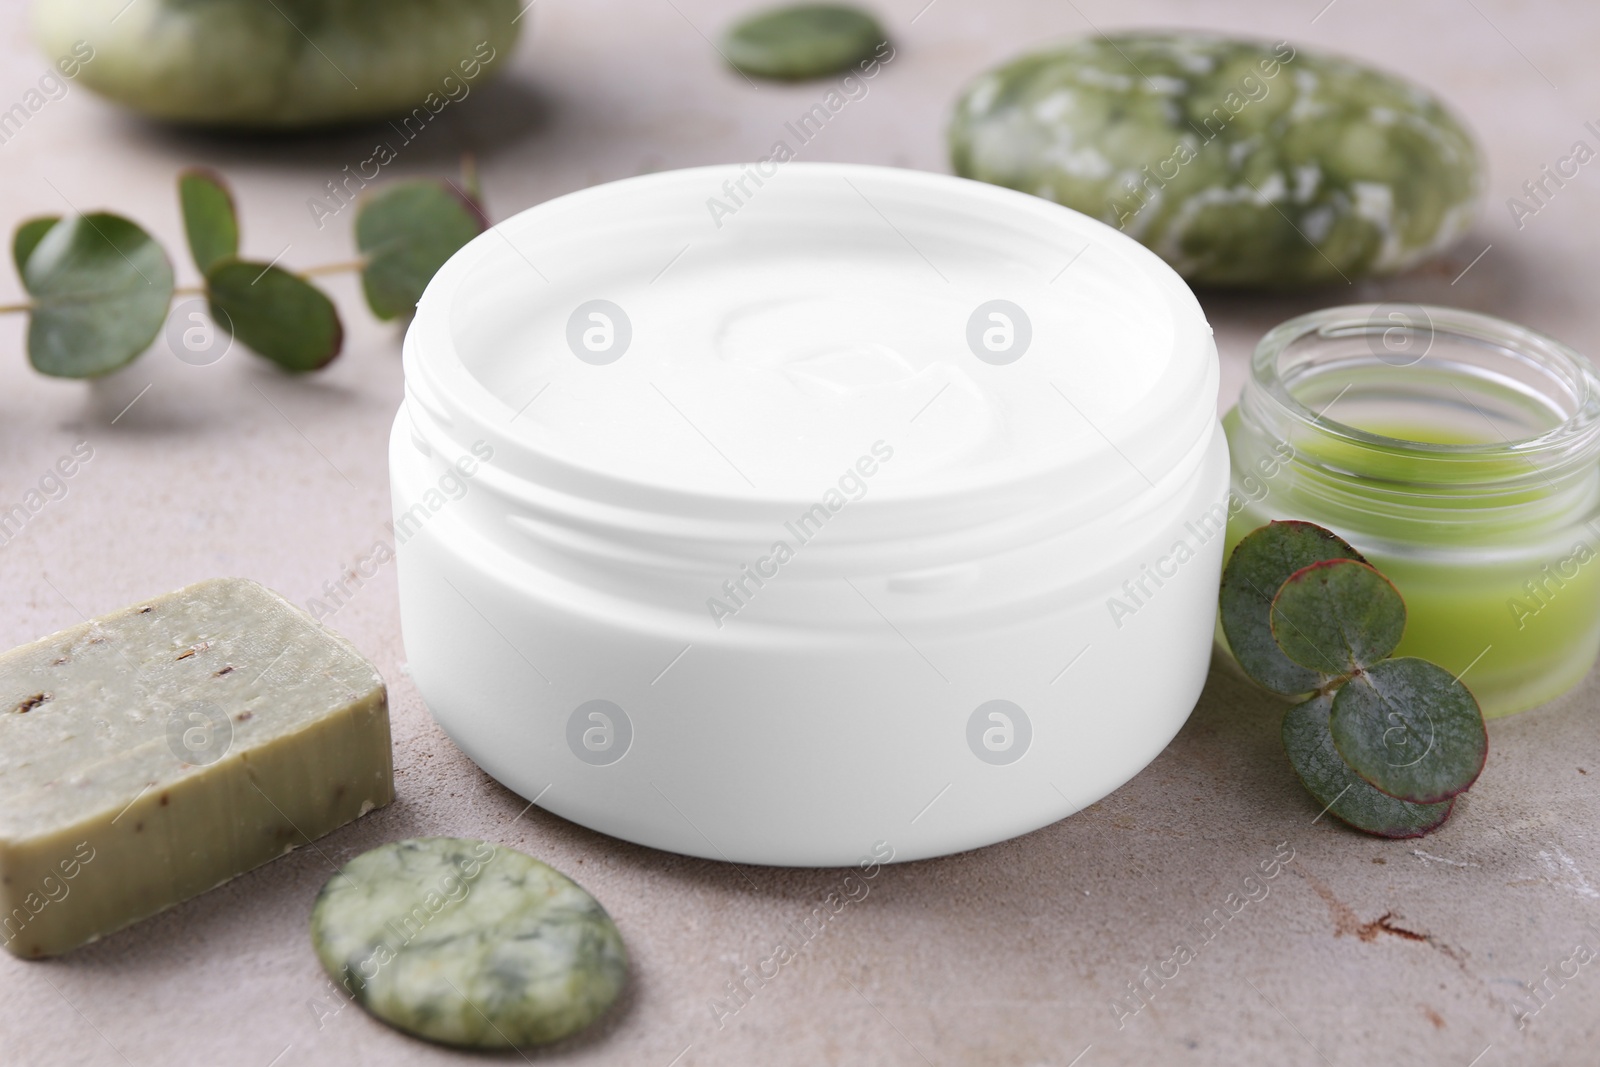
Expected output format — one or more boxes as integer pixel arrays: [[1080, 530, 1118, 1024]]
[[1222, 304, 1600, 718]]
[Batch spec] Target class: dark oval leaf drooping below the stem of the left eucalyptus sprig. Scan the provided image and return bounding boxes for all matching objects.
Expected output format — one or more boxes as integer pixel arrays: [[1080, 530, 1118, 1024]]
[[205, 259, 344, 371]]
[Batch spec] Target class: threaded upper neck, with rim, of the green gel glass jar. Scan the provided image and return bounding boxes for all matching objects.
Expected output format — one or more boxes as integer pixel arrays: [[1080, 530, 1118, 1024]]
[[1235, 304, 1600, 537]]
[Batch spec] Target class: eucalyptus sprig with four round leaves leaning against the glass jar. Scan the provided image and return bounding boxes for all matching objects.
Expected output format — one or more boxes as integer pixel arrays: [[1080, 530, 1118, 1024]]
[[1221, 522, 1488, 837]]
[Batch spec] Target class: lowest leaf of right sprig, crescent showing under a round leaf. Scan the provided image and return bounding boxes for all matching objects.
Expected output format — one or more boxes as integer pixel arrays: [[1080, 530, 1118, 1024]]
[[1283, 693, 1456, 837]]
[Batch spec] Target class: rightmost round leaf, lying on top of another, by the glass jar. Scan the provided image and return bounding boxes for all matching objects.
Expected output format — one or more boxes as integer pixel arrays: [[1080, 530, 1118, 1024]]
[[1328, 656, 1490, 805]]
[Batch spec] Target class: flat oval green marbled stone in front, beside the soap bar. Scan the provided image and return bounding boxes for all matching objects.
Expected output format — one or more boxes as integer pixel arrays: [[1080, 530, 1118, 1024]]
[[310, 837, 627, 1049]]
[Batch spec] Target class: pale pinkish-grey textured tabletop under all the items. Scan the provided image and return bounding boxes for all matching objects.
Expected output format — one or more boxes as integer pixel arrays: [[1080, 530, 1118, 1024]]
[[0, 0, 1600, 1067]]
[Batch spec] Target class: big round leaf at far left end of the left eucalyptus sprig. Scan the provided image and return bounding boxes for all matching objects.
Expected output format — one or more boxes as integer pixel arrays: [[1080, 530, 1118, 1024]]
[[22, 214, 173, 378]]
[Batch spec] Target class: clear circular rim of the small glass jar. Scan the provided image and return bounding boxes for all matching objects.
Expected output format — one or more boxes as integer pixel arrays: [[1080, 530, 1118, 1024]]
[[1246, 302, 1600, 462]]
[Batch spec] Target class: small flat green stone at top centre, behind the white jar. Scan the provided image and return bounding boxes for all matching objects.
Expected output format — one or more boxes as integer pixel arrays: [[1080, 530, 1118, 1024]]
[[722, 3, 885, 82]]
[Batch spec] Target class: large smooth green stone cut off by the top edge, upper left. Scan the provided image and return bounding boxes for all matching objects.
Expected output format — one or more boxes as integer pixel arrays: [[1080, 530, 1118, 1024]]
[[34, 0, 526, 129]]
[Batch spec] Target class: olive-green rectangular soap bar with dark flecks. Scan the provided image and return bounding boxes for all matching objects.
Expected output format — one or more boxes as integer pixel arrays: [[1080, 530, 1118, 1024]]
[[0, 577, 394, 957]]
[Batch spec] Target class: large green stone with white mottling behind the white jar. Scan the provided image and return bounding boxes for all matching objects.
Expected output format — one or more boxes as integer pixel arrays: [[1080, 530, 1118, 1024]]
[[949, 34, 1483, 286]]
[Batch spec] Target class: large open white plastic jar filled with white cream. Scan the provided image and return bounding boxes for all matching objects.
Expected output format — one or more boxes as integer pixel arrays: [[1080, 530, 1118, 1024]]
[[390, 163, 1227, 865]]
